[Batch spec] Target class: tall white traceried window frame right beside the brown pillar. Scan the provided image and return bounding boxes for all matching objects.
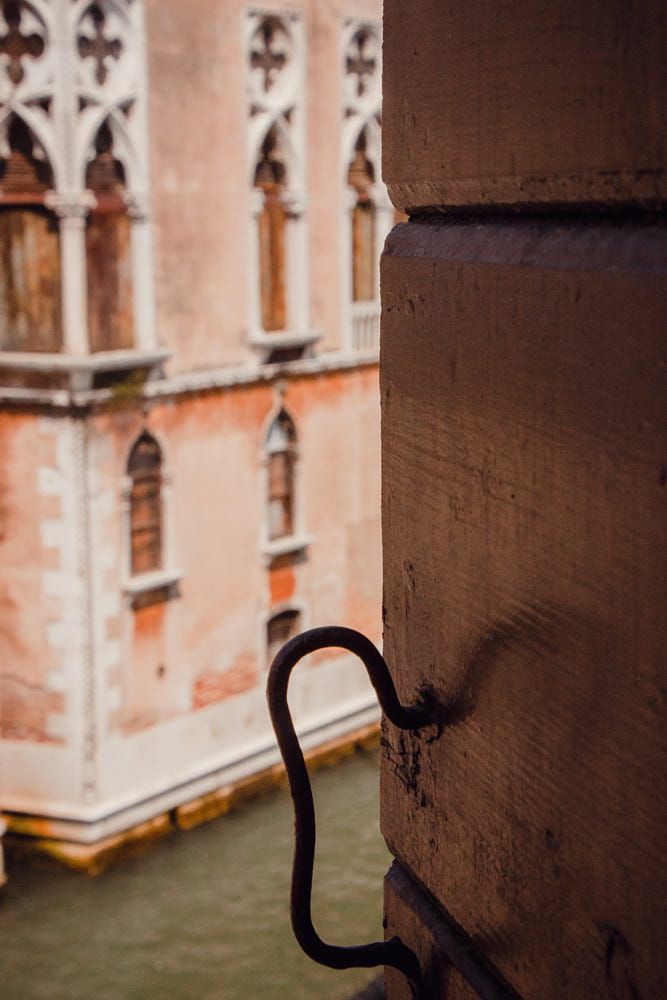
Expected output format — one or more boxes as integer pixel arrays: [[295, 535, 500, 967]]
[[340, 17, 394, 354]]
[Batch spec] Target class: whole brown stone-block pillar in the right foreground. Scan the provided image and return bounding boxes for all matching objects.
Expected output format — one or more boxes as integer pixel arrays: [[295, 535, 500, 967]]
[[380, 0, 667, 1000]]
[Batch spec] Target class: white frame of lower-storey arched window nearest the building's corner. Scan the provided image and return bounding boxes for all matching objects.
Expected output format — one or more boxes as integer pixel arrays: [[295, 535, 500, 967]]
[[120, 427, 183, 608]]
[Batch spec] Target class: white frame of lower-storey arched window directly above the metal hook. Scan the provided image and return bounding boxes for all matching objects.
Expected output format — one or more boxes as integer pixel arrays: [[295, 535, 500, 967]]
[[259, 402, 313, 568]]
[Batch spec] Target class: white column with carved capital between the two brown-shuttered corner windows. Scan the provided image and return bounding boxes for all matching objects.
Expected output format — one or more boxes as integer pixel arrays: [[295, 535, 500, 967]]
[[46, 192, 95, 354]]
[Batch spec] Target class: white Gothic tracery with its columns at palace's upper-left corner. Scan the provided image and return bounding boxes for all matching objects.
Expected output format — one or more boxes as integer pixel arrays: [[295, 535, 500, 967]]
[[0, 0, 155, 353]]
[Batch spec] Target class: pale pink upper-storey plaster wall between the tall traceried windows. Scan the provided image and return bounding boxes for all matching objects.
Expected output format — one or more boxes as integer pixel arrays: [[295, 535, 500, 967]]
[[146, 0, 381, 371]]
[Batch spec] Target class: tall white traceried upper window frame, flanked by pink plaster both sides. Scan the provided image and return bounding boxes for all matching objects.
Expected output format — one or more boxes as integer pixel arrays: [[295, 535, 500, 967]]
[[243, 7, 322, 363]]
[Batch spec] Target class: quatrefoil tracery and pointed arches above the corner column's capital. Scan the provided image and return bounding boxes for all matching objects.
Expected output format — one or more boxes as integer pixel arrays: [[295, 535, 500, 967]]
[[0, 0, 148, 197]]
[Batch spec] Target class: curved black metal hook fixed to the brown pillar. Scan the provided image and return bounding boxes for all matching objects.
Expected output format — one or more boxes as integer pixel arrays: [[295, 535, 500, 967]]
[[267, 625, 433, 1000]]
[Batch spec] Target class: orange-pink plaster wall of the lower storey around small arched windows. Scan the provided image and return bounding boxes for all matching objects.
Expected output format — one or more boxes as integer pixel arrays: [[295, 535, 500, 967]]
[[91, 366, 380, 732]]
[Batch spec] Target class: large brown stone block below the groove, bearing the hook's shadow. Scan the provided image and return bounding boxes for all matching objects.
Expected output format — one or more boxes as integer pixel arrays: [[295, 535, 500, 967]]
[[381, 219, 667, 1000]]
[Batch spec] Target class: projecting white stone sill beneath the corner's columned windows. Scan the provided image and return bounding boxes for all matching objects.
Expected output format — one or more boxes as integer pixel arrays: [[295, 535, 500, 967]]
[[0, 347, 171, 391]]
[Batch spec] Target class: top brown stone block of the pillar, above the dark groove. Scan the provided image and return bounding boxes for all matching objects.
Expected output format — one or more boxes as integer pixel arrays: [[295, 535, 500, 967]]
[[383, 0, 667, 211]]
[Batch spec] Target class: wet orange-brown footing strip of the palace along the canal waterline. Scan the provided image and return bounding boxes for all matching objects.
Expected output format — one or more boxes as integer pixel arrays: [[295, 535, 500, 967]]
[[0, 721, 380, 886]]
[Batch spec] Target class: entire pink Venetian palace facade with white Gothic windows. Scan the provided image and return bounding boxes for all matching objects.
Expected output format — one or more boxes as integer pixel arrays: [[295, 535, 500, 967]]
[[0, 0, 386, 854]]
